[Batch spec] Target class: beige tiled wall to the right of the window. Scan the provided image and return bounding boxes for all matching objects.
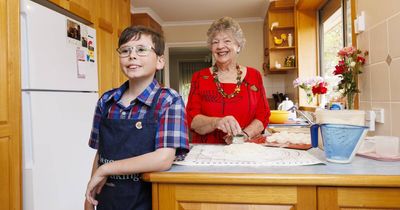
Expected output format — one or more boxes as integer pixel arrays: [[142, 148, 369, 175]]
[[356, 0, 400, 136]]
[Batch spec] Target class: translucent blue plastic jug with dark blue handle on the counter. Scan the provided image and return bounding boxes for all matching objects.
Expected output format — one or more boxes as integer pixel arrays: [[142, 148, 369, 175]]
[[311, 124, 368, 163]]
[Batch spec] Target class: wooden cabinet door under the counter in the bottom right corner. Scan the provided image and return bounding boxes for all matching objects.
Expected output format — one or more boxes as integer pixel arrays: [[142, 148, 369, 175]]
[[318, 187, 400, 210]]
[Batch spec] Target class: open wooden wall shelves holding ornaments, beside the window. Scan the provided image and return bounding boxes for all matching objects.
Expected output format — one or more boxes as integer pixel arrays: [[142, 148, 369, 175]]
[[264, 0, 297, 74]]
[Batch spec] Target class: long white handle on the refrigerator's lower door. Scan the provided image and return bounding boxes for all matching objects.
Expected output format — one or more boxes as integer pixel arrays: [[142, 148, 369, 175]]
[[22, 91, 34, 169]]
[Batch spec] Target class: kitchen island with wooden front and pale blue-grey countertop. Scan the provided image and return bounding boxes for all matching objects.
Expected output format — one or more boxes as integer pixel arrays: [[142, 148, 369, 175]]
[[143, 149, 400, 210]]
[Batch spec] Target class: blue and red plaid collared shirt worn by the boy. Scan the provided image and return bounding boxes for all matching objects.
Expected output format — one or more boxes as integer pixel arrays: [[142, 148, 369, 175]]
[[89, 80, 189, 155]]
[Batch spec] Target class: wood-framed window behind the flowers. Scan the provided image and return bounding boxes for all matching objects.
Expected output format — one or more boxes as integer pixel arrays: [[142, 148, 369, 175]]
[[318, 0, 352, 76]]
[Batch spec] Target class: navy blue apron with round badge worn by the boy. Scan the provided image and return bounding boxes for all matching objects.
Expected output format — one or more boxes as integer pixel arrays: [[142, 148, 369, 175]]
[[96, 88, 161, 210]]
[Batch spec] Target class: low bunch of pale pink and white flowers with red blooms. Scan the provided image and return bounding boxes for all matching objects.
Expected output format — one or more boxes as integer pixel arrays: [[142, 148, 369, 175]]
[[293, 75, 342, 105]]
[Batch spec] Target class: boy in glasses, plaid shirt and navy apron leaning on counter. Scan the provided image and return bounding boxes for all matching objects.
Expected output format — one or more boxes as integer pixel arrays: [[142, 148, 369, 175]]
[[85, 26, 189, 210]]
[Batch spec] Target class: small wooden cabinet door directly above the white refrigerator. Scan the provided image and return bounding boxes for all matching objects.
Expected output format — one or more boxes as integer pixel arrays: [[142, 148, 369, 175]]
[[49, 0, 95, 22]]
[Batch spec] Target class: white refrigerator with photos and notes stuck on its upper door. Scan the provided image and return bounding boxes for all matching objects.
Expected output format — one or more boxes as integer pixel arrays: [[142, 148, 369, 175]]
[[21, 0, 98, 210]]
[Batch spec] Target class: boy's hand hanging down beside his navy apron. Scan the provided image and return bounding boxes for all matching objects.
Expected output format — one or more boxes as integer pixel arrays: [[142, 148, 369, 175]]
[[85, 165, 107, 207]]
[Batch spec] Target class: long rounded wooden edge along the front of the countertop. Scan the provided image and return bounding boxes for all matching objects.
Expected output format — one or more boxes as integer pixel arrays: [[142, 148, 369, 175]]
[[143, 172, 400, 187]]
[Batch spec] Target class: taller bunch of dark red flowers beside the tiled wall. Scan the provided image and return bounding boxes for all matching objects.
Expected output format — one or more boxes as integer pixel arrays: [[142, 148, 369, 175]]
[[333, 47, 368, 109]]
